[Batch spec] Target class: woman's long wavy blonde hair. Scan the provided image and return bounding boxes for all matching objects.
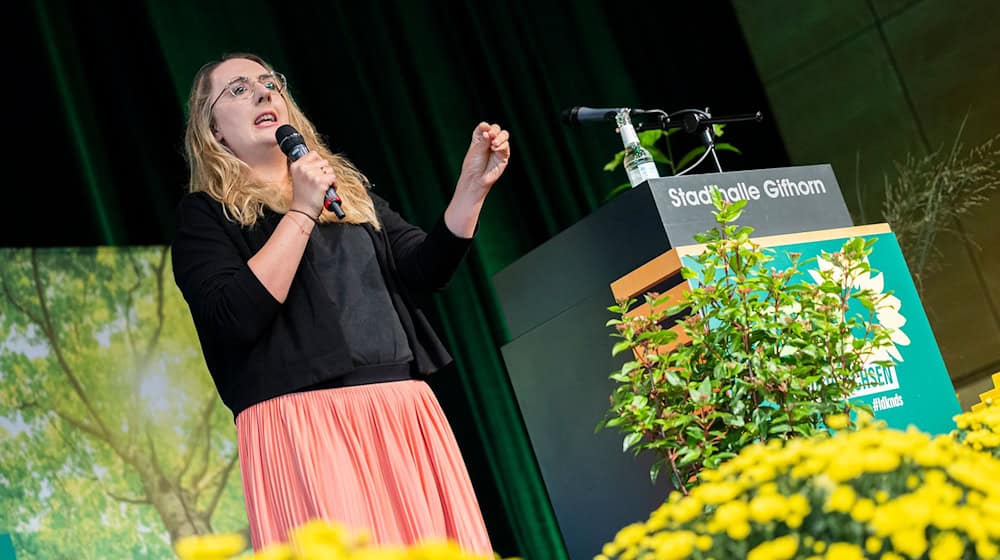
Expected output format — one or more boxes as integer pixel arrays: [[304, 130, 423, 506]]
[[184, 53, 380, 229]]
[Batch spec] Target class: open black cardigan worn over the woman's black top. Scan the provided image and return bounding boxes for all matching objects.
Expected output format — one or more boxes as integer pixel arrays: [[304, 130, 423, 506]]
[[171, 193, 471, 417]]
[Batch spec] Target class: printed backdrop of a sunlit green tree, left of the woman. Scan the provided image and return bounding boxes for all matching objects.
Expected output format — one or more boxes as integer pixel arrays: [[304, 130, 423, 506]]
[[0, 247, 247, 558]]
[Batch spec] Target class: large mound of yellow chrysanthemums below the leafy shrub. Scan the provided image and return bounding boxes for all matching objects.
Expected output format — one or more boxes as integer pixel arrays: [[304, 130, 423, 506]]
[[595, 418, 1000, 560]]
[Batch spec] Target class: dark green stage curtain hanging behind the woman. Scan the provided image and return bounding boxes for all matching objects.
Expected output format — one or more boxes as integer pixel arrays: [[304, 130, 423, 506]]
[[11, 0, 784, 558]]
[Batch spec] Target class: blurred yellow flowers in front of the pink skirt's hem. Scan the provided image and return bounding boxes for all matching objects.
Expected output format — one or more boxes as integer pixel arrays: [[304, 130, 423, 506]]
[[174, 521, 500, 560]]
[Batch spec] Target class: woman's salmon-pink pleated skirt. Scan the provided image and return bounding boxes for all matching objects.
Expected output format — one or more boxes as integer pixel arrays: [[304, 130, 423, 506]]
[[236, 381, 492, 556]]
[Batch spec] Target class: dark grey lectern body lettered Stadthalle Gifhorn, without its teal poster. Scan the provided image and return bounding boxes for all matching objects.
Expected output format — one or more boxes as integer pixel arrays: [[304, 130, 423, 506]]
[[493, 165, 853, 560]]
